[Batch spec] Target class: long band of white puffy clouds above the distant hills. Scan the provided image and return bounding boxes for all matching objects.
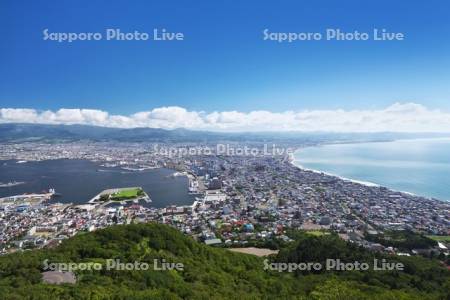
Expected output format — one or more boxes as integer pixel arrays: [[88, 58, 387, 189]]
[[0, 103, 450, 132]]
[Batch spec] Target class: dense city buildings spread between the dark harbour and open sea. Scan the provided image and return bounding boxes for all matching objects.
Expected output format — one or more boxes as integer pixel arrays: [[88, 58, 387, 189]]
[[0, 142, 450, 255]]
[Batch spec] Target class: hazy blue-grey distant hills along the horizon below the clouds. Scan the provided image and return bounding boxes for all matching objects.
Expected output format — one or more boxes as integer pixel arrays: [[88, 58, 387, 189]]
[[0, 123, 450, 144]]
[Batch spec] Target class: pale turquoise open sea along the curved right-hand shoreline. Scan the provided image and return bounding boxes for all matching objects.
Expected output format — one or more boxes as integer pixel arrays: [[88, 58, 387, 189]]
[[294, 139, 450, 201]]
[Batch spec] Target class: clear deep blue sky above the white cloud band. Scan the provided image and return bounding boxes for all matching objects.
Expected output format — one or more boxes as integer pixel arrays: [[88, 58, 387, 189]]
[[0, 0, 450, 115]]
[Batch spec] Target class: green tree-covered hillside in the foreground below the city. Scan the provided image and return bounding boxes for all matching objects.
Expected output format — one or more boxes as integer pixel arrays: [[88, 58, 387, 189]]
[[0, 224, 450, 300]]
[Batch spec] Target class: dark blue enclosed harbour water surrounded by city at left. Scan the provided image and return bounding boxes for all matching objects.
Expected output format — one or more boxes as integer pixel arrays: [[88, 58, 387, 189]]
[[0, 159, 195, 208]]
